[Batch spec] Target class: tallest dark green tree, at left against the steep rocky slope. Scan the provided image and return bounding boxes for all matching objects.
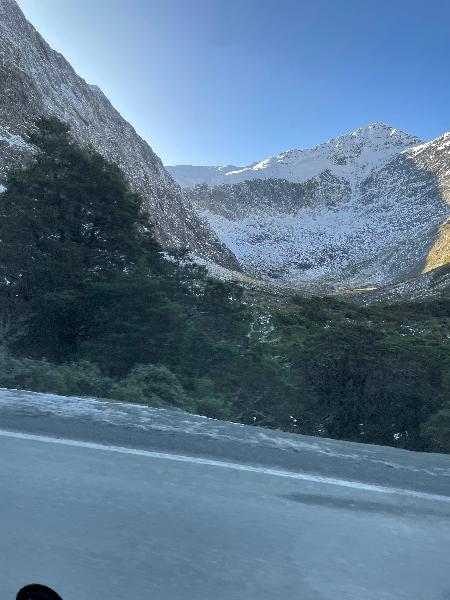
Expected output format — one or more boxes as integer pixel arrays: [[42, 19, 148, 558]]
[[0, 118, 170, 360]]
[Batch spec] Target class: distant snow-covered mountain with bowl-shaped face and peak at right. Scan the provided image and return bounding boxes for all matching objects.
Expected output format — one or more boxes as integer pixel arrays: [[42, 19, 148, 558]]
[[170, 123, 450, 289]]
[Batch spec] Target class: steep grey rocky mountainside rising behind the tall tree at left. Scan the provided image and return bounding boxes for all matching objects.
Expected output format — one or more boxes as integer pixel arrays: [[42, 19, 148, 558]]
[[0, 0, 239, 269]]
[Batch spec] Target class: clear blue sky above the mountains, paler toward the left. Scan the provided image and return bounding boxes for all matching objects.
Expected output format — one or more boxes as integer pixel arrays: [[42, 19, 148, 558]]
[[18, 0, 450, 165]]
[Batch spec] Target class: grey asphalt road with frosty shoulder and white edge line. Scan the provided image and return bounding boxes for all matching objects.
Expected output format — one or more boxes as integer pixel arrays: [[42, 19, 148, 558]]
[[0, 390, 450, 600]]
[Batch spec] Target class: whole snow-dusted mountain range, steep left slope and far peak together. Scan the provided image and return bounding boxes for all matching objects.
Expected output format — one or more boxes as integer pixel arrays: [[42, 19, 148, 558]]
[[0, 0, 450, 297]]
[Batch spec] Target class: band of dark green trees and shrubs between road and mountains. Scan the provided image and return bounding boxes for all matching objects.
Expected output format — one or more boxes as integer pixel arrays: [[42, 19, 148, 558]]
[[0, 119, 450, 451]]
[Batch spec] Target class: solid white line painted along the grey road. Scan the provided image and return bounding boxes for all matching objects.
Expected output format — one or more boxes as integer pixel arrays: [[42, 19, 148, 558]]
[[0, 430, 450, 504]]
